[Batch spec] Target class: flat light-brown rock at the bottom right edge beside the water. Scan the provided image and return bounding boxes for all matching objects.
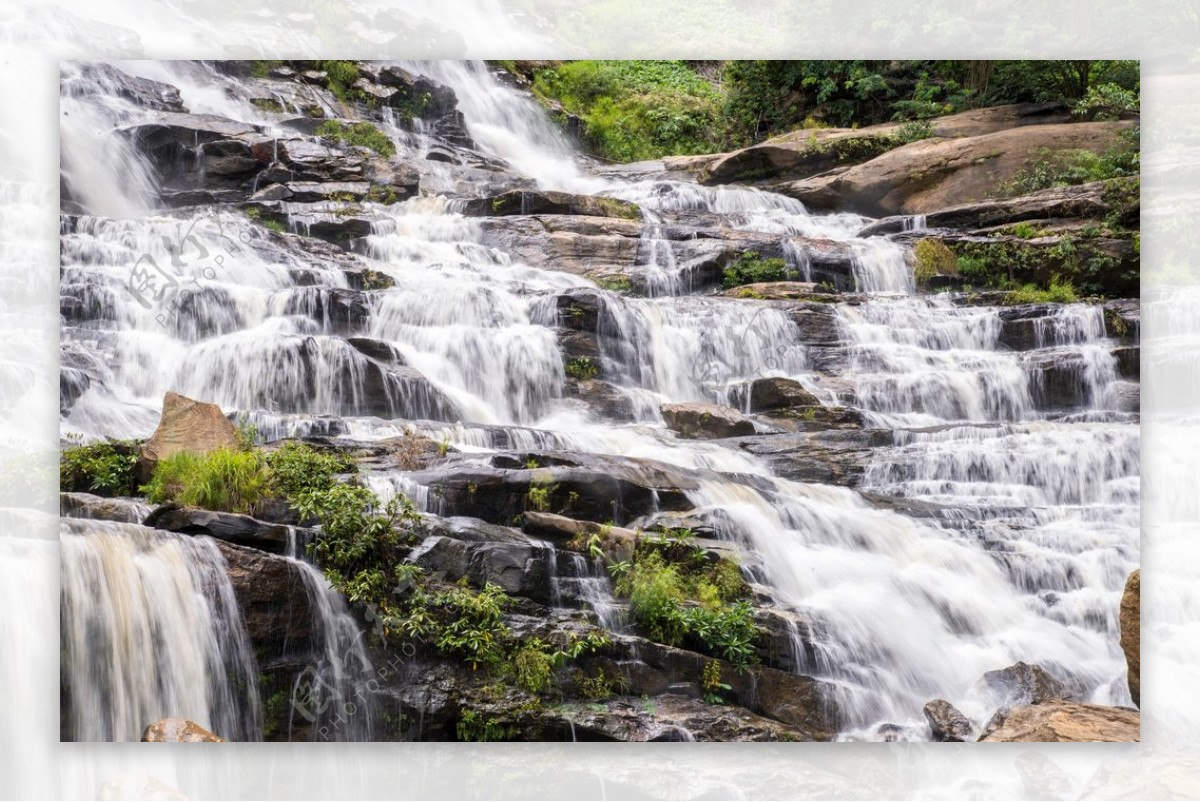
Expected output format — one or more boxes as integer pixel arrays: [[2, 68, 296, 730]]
[[979, 701, 1141, 742]]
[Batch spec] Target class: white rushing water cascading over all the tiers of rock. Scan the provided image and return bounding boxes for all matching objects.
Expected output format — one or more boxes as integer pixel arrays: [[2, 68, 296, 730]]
[[62, 62, 1139, 738]]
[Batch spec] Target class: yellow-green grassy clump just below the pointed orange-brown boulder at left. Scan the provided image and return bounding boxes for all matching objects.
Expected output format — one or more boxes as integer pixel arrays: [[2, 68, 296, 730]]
[[142, 448, 271, 514]]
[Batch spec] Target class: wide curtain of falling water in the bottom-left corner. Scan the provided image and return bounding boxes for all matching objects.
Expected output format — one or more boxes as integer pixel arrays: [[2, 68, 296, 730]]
[[61, 519, 263, 741]]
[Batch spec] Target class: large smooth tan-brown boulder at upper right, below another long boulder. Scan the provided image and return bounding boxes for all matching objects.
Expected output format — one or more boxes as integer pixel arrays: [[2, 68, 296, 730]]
[[772, 122, 1132, 217]]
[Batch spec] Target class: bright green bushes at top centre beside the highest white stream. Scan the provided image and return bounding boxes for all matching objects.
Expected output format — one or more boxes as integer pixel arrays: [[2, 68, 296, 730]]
[[533, 60, 720, 161]]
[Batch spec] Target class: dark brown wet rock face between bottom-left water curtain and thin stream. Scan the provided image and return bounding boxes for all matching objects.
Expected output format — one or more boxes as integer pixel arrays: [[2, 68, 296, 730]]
[[217, 540, 314, 665]]
